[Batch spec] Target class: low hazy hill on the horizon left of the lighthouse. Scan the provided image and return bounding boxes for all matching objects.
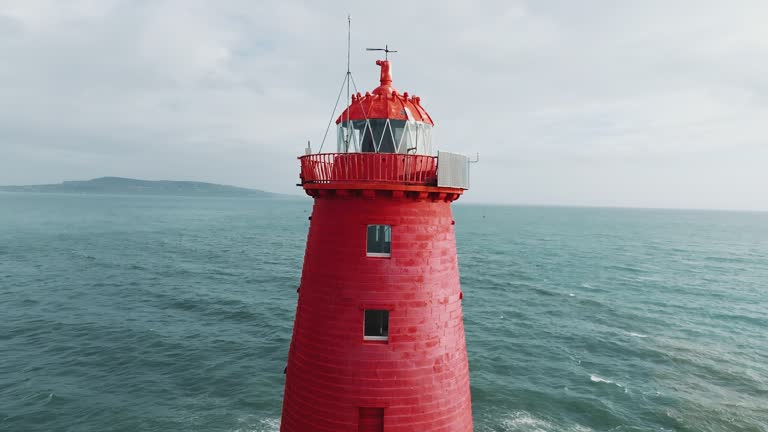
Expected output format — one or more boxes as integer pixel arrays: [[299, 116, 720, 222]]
[[0, 177, 290, 198]]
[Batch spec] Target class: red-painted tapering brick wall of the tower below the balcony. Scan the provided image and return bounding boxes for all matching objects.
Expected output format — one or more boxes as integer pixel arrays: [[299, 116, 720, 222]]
[[280, 193, 472, 432]]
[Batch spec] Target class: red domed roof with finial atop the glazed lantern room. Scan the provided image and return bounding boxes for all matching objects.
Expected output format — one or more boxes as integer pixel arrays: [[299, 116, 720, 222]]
[[336, 60, 434, 125]]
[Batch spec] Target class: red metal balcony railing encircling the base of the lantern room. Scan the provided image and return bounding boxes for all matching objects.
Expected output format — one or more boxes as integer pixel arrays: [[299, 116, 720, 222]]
[[299, 153, 437, 186]]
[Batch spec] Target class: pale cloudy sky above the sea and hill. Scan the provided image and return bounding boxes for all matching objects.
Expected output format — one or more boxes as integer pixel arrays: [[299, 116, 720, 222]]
[[0, 0, 768, 210]]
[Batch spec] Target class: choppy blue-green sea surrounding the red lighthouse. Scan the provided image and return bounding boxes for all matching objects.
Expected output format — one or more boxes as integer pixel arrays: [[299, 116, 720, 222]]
[[0, 193, 768, 432]]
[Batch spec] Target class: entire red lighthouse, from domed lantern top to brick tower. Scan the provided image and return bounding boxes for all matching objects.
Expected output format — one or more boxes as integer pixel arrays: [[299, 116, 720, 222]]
[[280, 60, 472, 432]]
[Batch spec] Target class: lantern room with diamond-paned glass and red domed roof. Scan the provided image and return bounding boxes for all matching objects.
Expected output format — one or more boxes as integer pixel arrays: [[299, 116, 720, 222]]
[[336, 60, 434, 155]]
